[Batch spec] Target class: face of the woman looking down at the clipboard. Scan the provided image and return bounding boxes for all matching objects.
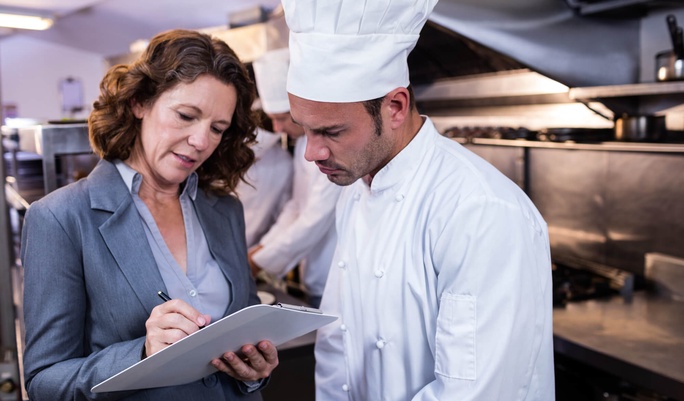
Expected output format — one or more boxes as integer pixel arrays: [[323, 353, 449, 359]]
[[131, 75, 237, 189]]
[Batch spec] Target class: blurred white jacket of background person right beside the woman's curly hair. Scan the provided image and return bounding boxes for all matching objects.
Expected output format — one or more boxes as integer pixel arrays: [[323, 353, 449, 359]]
[[235, 129, 294, 248]]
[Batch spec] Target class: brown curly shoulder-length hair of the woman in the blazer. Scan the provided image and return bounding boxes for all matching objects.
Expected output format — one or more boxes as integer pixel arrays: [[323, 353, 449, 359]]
[[88, 29, 257, 195]]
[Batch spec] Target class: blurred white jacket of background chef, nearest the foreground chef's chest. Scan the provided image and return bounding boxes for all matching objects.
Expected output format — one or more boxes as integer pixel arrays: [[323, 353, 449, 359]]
[[252, 136, 341, 296]]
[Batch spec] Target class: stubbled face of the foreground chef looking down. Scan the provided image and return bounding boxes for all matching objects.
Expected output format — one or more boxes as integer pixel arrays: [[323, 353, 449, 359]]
[[290, 94, 397, 185]]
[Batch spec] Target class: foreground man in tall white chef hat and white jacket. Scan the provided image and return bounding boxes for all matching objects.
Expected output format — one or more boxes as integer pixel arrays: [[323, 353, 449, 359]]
[[283, 0, 555, 401]]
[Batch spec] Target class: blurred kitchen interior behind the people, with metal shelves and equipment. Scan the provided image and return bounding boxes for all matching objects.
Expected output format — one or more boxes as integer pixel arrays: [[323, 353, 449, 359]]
[[0, 0, 684, 401]]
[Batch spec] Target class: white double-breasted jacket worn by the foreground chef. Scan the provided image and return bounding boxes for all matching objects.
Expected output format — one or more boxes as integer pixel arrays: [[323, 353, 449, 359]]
[[315, 117, 555, 401]]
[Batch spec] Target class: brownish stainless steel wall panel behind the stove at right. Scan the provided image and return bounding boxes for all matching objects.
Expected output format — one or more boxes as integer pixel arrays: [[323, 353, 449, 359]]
[[528, 148, 684, 274]]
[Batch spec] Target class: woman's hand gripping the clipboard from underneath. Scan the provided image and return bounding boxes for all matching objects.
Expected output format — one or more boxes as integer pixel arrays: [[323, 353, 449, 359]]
[[211, 340, 278, 382]]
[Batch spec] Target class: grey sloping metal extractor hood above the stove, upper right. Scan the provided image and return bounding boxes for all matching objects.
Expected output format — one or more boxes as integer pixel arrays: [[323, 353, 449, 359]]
[[412, 0, 640, 87]]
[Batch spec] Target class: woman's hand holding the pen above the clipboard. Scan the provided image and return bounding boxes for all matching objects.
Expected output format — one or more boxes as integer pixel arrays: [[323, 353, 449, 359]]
[[142, 299, 211, 358]]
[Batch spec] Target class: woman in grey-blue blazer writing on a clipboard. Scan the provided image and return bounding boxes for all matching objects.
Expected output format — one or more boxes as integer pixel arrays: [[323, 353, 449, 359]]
[[21, 30, 278, 401]]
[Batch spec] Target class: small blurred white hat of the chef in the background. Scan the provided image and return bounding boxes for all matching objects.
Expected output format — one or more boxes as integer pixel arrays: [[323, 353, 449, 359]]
[[252, 48, 290, 114]]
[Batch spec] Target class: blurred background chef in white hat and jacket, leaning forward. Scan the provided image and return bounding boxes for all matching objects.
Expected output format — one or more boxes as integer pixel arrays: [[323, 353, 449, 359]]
[[249, 48, 340, 307]]
